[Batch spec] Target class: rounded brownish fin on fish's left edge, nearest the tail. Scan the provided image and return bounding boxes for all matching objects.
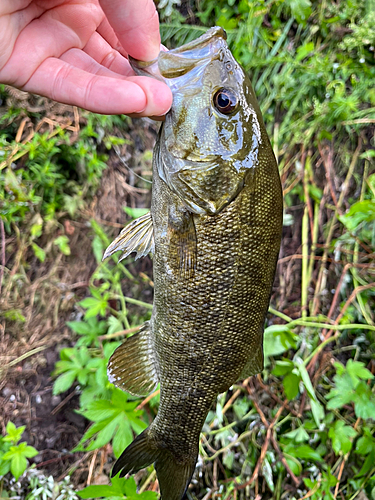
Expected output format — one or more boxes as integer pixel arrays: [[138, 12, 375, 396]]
[[107, 321, 158, 396]]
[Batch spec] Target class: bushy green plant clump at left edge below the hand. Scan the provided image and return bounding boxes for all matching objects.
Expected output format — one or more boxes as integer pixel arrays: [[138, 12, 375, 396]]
[[0, 130, 106, 229]]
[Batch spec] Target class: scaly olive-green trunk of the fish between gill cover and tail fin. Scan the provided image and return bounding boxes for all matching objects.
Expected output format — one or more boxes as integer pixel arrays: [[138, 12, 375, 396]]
[[152, 142, 280, 446]]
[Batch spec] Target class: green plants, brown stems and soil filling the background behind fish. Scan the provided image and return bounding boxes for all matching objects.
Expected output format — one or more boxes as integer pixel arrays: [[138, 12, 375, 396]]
[[0, 0, 375, 500]]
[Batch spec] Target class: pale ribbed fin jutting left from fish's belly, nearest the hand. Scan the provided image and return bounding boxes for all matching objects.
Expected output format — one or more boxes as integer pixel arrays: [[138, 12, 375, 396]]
[[103, 212, 154, 261]]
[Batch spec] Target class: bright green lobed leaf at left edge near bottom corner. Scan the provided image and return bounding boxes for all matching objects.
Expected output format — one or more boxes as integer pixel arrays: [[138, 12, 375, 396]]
[[0, 422, 38, 480]]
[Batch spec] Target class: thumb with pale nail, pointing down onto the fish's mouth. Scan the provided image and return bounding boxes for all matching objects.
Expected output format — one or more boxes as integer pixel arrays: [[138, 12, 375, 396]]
[[100, 0, 160, 61]]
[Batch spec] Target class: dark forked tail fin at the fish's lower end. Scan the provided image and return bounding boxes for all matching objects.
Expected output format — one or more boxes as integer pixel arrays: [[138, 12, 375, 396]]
[[112, 428, 197, 500]]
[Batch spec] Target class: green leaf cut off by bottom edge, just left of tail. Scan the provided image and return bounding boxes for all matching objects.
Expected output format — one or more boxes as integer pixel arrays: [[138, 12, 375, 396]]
[[78, 476, 157, 500]]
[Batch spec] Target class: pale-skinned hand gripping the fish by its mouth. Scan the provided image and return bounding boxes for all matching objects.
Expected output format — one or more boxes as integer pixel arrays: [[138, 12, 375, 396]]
[[0, 0, 172, 117]]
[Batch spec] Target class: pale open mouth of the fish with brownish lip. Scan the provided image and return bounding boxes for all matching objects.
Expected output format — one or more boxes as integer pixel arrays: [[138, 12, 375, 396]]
[[128, 26, 227, 84]]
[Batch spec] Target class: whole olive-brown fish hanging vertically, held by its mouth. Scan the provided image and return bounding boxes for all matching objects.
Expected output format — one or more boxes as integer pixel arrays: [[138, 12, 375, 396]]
[[104, 27, 283, 500]]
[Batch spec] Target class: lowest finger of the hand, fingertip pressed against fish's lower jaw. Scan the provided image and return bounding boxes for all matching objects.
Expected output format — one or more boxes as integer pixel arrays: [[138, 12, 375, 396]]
[[23, 58, 172, 116]]
